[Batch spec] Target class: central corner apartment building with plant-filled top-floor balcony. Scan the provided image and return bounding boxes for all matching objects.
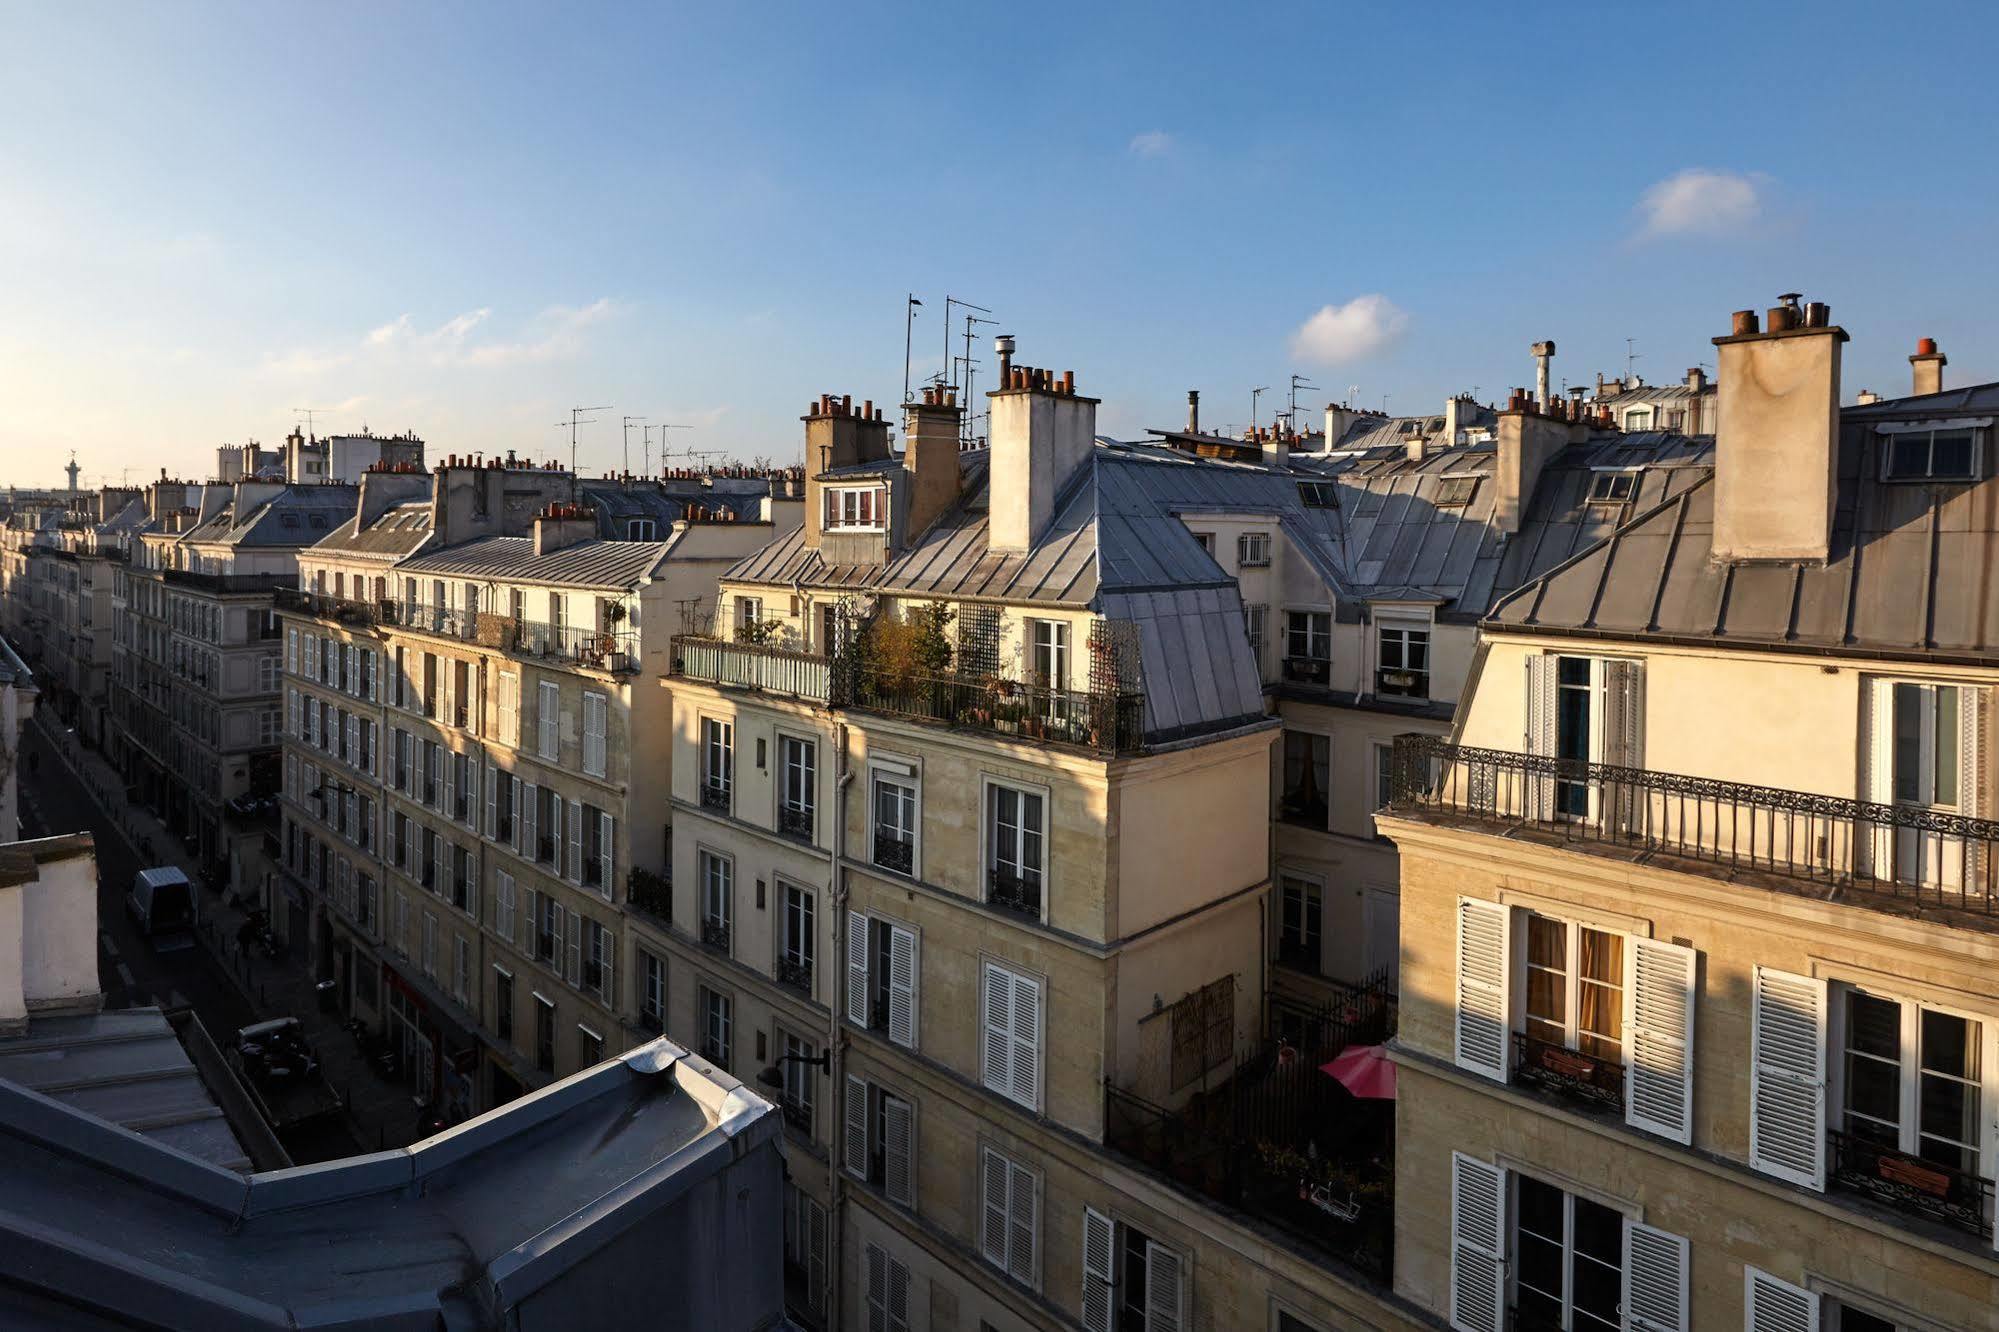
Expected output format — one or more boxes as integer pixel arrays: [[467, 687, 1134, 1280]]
[[663, 370, 1463, 1332]]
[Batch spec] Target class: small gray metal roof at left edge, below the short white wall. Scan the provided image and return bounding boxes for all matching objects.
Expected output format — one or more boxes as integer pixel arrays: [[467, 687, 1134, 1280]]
[[0, 1008, 250, 1170]]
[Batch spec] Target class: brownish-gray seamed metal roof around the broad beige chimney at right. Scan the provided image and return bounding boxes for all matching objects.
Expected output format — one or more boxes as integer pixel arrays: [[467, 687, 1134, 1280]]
[[1491, 384, 1999, 660]]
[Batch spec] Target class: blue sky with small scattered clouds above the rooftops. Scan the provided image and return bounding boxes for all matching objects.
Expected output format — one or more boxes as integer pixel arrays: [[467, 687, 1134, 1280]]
[[0, 0, 1999, 486]]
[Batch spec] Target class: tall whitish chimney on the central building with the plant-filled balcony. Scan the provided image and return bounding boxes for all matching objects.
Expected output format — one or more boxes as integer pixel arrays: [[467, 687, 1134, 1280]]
[[986, 352, 1097, 554]]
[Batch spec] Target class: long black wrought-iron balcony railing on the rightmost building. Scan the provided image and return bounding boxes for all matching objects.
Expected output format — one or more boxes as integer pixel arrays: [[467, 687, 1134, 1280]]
[[1389, 736, 1999, 914]]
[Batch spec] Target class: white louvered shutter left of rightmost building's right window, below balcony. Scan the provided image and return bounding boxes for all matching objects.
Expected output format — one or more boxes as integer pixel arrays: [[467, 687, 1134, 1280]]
[[1749, 966, 1825, 1190]]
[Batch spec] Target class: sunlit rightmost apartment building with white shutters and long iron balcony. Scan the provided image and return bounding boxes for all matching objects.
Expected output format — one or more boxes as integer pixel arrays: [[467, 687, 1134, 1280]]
[[1379, 304, 1999, 1332]]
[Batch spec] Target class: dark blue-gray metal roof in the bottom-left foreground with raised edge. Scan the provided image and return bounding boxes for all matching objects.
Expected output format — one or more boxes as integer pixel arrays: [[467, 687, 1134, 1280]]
[[0, 1040, 782, 1332]]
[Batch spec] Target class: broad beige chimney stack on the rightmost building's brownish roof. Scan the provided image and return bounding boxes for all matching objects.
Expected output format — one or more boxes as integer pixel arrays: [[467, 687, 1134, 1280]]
[[1713, 296, 1847, 562]]
